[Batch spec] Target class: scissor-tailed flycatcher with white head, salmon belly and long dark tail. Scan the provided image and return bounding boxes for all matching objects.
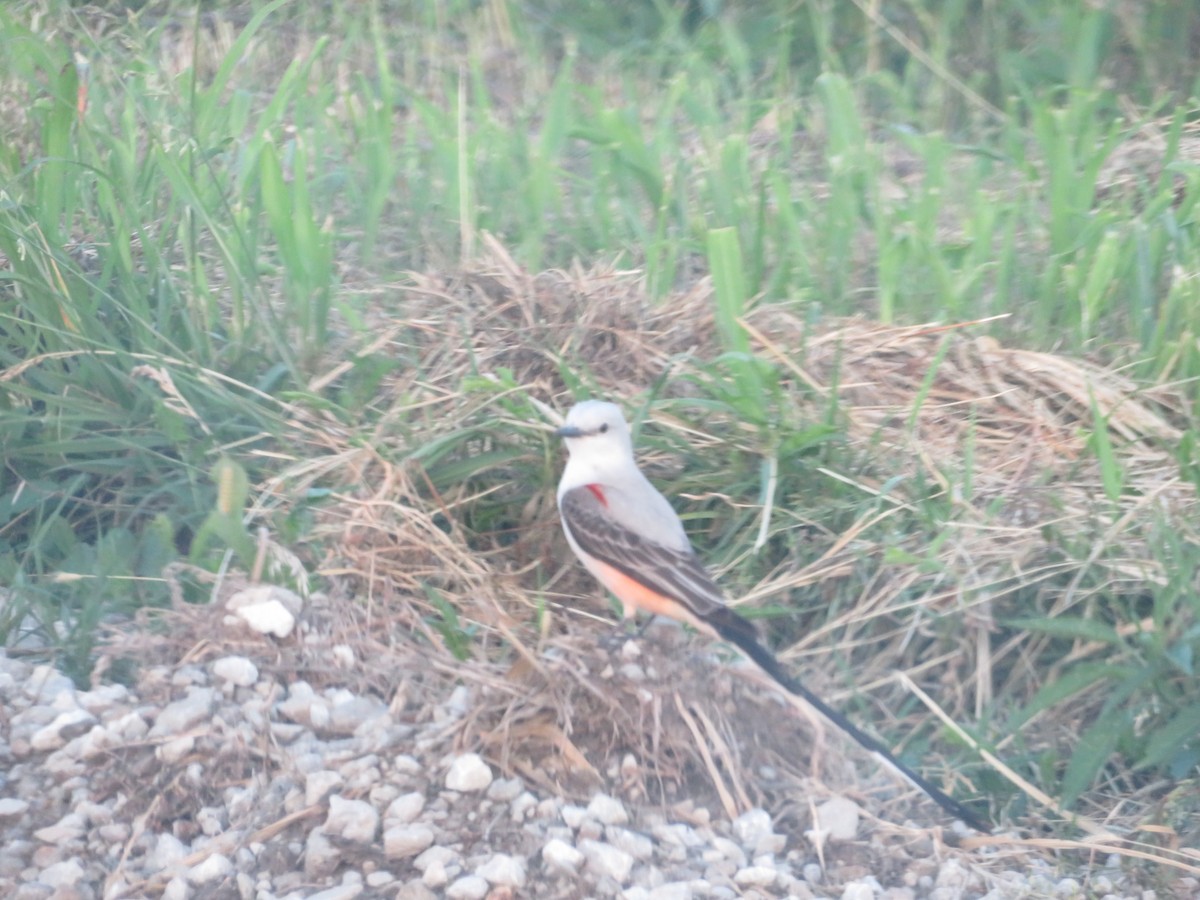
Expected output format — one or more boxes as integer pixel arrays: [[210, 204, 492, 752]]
[[557, 400, 990, 832]]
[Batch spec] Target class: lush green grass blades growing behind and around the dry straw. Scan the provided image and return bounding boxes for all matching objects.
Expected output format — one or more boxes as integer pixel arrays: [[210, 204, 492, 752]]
[[0, 0, 1200, 830]]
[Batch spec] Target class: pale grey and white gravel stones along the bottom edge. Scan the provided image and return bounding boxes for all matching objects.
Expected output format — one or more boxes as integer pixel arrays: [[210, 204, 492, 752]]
[[0, 638, 1180, 900]]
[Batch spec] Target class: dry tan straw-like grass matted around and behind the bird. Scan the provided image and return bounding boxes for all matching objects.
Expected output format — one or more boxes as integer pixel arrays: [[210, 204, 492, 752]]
[[96, 244, 1195, 888]]
